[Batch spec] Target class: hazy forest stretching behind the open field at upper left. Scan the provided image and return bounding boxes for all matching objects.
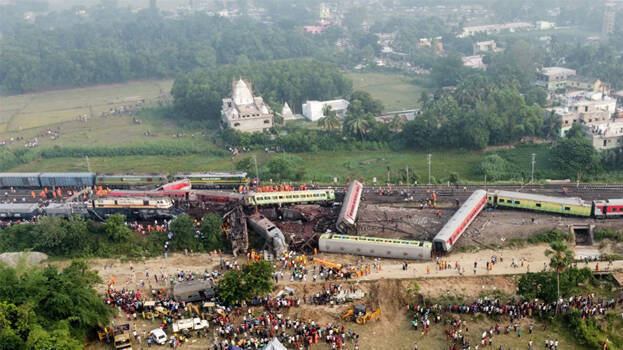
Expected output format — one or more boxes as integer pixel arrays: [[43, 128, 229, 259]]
[[0, 5, 333, 93]]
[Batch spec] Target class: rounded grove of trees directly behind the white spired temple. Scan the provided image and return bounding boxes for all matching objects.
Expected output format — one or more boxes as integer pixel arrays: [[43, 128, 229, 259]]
[[171, 59, 352, 120]]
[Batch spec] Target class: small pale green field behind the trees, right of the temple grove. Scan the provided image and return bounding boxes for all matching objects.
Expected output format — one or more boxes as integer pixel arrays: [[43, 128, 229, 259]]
[[347, 73, 422, 112]]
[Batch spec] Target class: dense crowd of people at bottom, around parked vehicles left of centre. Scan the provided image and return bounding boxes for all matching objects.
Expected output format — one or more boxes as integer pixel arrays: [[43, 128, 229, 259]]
[[100, 286, 359, 350]]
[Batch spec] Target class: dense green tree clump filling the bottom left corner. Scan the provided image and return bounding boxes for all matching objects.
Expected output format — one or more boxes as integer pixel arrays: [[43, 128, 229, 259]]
[[0, 262, 114, 350]]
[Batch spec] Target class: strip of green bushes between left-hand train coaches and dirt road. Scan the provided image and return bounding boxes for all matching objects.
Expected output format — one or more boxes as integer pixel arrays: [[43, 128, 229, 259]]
[[0, 214, 226, 258]]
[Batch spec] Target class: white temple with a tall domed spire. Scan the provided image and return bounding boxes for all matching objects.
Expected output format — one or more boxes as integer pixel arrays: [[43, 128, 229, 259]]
[[221, 79, 273, 132]]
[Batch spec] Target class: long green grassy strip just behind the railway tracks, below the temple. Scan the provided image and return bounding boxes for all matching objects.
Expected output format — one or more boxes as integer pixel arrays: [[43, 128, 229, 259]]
[[11, 151, 484, 183]]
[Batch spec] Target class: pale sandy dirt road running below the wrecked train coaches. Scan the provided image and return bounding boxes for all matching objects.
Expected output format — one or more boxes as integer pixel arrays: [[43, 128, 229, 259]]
[[90, 244, 623, 291]]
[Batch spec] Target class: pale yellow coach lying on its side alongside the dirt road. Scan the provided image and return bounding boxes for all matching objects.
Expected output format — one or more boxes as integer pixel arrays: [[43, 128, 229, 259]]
[[318, 233, 433, 260]]
